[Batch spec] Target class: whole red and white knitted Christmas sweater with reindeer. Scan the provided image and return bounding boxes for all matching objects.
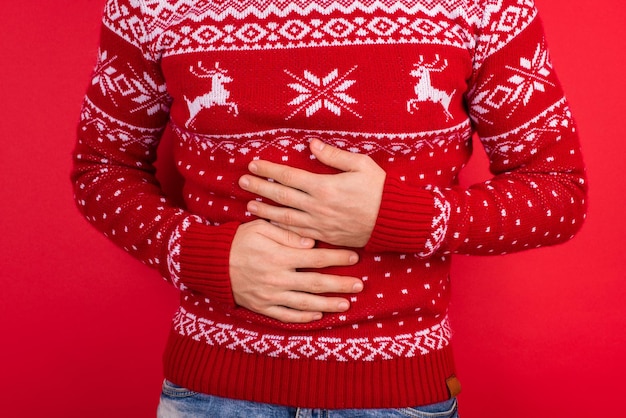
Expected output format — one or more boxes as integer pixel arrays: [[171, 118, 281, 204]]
[[72, 0, 586, 408]]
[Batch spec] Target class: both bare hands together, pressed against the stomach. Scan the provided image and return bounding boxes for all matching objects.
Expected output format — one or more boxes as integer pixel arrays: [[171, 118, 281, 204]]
[[230, 139, 385, 323]]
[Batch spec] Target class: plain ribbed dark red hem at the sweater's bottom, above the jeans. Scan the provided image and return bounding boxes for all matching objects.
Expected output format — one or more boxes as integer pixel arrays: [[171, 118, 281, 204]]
[[164, 320, 455, 409]]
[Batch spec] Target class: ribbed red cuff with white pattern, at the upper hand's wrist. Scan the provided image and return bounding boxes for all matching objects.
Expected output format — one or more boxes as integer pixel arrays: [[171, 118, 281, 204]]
[[365, 178, 450, 258]]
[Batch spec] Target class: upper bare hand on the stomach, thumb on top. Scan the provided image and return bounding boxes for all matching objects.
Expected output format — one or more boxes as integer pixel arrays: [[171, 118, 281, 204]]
[[239, 139, 386, 248]]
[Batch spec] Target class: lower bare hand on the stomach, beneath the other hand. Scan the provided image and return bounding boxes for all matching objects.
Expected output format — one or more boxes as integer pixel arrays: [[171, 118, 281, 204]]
[[230, 219, 363, 323]]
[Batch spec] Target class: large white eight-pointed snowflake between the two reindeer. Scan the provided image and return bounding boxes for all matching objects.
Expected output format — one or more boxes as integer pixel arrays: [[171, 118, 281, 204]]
[[285, 65, 362, 120]]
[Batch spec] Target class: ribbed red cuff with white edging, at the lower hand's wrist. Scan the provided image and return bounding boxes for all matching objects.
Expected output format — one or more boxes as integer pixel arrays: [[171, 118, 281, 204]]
[[168, 216, 239, 306]]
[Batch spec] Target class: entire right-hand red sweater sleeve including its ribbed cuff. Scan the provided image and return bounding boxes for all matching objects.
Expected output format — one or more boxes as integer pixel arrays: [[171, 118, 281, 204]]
[[368, 1, 587, 257]]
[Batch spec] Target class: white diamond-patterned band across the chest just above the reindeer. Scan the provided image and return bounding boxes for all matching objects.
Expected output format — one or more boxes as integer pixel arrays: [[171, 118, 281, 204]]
[[153, 13, 473, 57]]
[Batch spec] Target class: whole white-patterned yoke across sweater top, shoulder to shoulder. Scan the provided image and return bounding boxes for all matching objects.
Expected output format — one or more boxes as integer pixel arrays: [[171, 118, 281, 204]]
[[103, 0, 536, 59]]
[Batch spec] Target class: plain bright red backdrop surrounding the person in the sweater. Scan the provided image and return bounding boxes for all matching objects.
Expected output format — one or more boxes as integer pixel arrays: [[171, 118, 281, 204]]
[[0, 0, 626, 418]]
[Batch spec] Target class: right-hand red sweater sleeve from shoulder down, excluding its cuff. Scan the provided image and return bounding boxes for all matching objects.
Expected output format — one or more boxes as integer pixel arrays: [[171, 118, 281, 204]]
[[443, 4, 587, 254]]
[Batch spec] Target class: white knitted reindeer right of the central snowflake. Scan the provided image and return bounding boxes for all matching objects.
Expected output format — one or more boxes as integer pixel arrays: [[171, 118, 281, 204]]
[[406, 54, 456, 121]]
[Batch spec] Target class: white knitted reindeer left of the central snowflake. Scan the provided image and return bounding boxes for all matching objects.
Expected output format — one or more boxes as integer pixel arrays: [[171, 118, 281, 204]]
[[184, 61, 239, 128]]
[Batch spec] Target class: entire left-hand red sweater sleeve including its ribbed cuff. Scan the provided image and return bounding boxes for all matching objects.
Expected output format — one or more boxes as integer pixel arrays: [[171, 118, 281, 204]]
[[71, 0, 238, 304]]
